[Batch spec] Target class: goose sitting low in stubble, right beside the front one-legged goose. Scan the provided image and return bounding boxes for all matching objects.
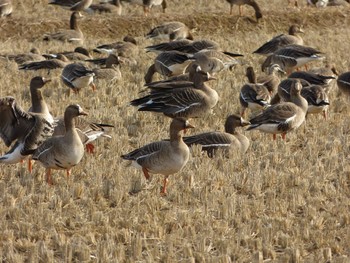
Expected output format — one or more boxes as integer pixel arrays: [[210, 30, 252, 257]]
[[183, 115, 250, 157]]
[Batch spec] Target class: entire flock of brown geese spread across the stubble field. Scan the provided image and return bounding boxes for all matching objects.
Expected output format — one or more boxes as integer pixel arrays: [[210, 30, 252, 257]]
[[0, 0, 350, 194]]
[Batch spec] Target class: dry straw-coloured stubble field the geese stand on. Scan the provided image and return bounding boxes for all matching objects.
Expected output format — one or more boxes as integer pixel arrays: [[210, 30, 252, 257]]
[[0, 0, 350, 262]]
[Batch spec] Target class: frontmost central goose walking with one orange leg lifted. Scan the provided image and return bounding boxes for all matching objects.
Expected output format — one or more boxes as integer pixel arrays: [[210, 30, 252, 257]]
[[121, 119, 194, 194]]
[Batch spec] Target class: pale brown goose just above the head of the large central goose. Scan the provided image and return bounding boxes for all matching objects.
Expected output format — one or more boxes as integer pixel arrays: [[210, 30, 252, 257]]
[[192, 49, 243, 74]]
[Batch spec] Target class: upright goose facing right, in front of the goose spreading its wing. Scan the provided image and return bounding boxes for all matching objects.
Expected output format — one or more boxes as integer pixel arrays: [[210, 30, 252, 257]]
[[32, 104, 87, 185]]
